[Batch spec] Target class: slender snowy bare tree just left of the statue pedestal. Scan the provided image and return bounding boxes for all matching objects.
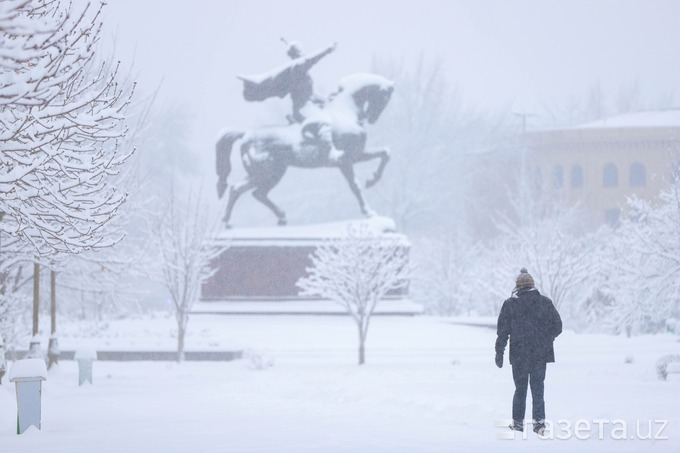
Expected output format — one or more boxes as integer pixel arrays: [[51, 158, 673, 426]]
[[150, 189, 224, 361]]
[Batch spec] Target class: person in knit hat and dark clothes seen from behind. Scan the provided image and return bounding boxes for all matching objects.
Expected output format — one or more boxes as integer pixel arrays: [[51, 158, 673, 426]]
[[496, 268, 562, 435]]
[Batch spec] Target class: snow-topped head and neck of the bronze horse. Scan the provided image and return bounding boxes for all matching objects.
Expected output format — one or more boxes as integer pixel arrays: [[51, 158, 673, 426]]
[[330, 74, 394, 124]]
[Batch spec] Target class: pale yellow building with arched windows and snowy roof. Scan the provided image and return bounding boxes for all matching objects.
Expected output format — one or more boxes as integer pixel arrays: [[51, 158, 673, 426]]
[[521, 109, 680, 225]]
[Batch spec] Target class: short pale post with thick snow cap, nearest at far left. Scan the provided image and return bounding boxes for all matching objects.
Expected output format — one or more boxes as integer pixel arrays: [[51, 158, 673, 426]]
[[9, 359, 47, 434]]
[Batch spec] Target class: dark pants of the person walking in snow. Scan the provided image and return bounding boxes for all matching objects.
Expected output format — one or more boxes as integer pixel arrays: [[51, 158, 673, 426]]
[[512, 363, 545, 426]]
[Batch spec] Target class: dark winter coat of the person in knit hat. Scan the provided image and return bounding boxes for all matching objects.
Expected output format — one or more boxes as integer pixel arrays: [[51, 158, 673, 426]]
[[496, 288, 562, 365]]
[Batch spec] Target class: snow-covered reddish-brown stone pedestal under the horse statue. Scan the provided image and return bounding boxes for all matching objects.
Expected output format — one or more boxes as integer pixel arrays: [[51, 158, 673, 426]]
[[197, 217, 422, 315]]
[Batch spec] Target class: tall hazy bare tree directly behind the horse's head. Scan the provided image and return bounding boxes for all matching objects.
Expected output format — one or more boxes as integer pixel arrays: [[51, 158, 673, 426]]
[[369, 56, 502, 234]]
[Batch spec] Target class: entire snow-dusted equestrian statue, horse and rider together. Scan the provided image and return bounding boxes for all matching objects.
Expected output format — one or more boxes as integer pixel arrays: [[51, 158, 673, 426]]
[[215, 43, 394, 226]]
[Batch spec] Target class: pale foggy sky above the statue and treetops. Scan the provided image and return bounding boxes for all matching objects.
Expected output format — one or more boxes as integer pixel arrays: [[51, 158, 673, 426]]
[[104, 0, 680, 181]]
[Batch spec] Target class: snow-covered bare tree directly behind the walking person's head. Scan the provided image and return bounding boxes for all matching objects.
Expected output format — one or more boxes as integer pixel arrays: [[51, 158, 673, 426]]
[[490, 159, 603, 321]]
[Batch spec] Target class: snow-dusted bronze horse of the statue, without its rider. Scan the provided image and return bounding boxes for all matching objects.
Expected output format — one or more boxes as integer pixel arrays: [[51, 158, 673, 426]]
[[215, 74, 394, 227]]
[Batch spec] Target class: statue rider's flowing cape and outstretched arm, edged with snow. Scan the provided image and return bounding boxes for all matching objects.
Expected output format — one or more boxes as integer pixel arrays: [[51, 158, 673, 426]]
[[236, 45, 328, 102]]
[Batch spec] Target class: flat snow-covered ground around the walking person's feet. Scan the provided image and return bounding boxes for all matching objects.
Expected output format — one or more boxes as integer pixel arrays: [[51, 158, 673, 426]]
[[0, 315, 680, 453]]
